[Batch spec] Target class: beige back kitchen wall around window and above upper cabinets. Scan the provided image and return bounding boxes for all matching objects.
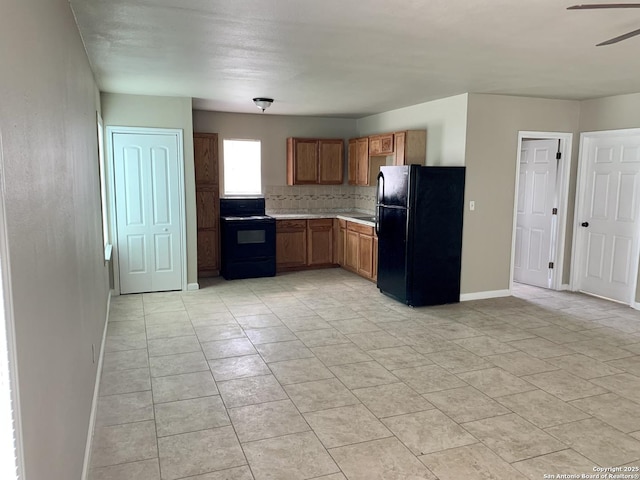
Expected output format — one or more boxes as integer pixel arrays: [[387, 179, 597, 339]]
[[193, 110, 356, 189]]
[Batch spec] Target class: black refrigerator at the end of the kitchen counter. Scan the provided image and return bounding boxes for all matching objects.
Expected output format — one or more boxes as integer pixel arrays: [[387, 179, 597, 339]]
[[376, 165, 465, 307]]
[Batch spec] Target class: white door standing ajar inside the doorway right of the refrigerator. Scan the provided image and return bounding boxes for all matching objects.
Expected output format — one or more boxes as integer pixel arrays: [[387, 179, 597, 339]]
[[513, 140, 558, 288]]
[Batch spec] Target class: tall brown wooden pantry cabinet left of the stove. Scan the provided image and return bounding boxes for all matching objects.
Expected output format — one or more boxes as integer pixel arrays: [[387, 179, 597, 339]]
[[193, 133, 220, 277]]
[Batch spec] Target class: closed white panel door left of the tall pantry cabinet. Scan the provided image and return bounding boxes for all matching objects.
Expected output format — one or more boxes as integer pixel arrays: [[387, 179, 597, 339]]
[[113, 133, 183, 293]]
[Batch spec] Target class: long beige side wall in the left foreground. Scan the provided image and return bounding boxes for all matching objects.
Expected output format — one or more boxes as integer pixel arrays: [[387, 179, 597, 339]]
[[0, 0, 108, 480]]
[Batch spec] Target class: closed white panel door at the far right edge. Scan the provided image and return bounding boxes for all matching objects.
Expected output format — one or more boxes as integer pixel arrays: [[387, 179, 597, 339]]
[[576, 134, 640, 304]]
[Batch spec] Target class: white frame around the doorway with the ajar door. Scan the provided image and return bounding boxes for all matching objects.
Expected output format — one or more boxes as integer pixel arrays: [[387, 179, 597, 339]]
[[509, 130, 573, 292]]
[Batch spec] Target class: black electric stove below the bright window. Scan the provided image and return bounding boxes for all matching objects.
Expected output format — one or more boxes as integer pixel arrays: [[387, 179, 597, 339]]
[[220, 197, 276, 280]]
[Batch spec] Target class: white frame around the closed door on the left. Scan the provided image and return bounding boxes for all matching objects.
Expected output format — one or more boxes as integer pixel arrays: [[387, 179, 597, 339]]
[[106, 125, 187, 295]]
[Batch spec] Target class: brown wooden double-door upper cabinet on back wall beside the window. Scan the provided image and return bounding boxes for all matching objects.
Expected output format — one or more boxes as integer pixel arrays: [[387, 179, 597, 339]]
[[287, 138, 344, 185]]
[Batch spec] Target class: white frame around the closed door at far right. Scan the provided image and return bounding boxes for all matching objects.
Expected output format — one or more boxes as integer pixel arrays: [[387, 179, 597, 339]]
[[570, 128, 640, 310]]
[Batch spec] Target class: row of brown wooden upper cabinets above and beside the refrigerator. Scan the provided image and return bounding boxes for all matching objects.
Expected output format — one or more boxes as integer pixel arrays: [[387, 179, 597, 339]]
[[348, 130, 427, 186]]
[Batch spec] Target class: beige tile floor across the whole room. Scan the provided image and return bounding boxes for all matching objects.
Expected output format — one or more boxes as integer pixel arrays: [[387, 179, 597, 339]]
[[90, 269, 640, 480]]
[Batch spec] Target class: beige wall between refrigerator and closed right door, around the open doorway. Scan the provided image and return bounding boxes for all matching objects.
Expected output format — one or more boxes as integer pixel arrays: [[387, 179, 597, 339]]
[[461, 94, 580, 293]]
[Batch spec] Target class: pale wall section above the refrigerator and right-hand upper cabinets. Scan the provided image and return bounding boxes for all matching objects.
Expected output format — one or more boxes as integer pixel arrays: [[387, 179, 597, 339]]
[[358, 93, 467, 166]]
